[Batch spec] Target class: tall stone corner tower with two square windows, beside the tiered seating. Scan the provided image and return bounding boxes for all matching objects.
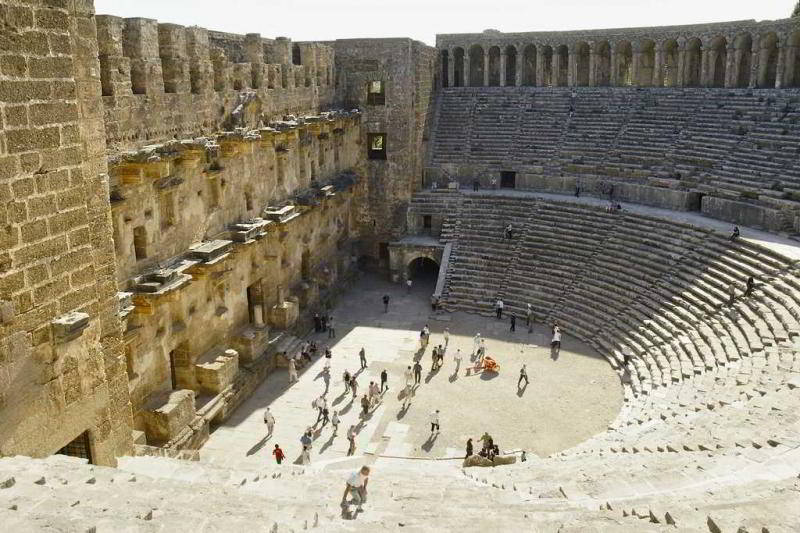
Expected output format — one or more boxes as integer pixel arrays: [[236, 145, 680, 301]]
[[334, 39, 435, 268]]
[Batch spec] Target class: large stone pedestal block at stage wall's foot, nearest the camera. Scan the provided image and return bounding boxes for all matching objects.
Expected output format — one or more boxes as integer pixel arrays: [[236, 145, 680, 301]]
[[142, 389, 195, 444]]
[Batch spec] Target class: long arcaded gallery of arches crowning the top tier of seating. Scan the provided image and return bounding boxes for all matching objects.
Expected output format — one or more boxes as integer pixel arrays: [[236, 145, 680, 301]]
[[436, 18, 800, 88]]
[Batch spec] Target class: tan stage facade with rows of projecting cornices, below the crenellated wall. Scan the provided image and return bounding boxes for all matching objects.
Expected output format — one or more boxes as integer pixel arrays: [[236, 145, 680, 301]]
[[111, 113, 364, 440]]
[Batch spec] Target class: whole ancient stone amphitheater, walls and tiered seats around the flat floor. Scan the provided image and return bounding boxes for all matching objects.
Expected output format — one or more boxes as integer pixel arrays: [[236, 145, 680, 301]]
[[0, 0, 800, 533]]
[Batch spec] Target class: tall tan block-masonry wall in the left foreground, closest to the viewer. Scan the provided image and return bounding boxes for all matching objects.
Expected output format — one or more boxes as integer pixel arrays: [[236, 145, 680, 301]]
[[0, 0, 133, 465]]
